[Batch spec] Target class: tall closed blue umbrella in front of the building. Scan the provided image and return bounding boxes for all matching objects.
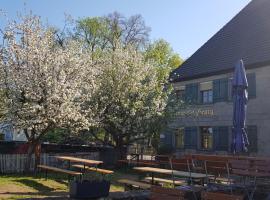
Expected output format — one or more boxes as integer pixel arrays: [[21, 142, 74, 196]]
[[232, 60, 249, 153]]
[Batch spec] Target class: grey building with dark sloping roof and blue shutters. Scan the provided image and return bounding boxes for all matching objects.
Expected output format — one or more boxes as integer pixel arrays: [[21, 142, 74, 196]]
[[161, 0, 270, 156]]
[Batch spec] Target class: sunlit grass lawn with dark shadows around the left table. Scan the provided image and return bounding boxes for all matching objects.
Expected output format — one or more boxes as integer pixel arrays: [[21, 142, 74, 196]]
[[0, 171, 136, 200]]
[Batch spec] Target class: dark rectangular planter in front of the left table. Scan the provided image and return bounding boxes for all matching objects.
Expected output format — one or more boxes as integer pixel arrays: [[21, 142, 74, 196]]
[[69, 180, 111, 199]]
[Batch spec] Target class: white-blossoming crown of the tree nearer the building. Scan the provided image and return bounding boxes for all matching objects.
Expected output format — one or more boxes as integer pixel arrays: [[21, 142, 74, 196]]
[[87, 45, 167, 156]]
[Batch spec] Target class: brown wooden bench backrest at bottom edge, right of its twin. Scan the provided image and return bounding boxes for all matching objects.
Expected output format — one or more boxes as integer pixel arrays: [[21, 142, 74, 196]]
[[201, 192, 244, 200]]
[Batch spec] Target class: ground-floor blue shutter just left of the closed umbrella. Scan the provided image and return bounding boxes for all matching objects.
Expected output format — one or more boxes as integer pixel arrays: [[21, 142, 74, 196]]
[[213, 126, 229, 151]]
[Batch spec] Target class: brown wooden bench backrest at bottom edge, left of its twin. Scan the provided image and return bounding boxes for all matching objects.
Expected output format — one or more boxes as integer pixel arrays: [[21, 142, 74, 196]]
[[150, 186, 187, 200]]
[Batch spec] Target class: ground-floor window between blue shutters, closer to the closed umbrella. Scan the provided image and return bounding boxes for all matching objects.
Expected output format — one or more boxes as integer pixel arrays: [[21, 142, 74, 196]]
[[200, 127, 213, 150]]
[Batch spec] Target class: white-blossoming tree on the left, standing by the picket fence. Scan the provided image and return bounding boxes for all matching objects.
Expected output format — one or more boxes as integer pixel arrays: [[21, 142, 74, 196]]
[[0, 15, 95, 170]]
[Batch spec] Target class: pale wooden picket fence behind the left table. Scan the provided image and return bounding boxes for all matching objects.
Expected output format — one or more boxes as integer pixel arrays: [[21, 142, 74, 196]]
[[0, 152, 100, 173]]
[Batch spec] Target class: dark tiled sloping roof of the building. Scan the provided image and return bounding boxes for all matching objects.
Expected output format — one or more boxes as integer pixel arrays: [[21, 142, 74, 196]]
[[170, 0, 270, 82]]
